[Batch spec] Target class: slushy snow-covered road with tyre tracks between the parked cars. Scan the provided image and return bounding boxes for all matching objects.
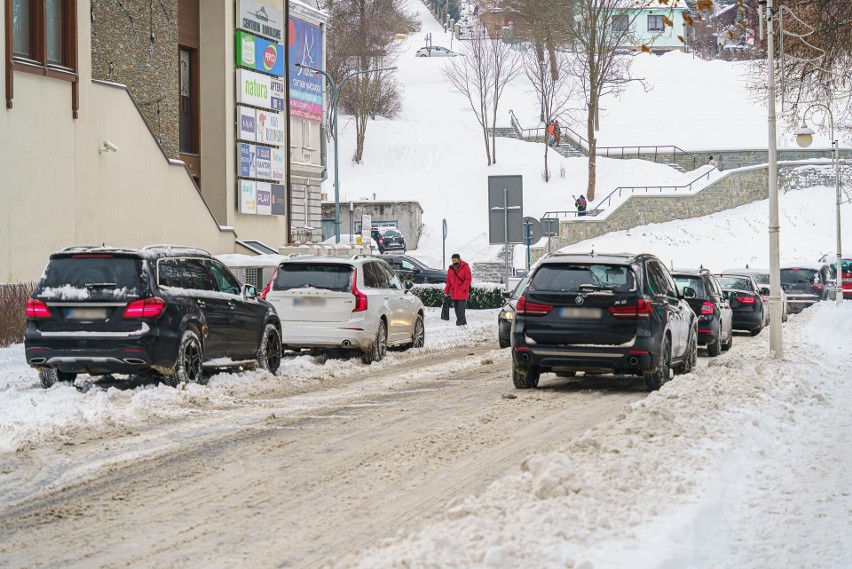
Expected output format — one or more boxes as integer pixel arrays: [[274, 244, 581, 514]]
[[0, 318, 684, 567]]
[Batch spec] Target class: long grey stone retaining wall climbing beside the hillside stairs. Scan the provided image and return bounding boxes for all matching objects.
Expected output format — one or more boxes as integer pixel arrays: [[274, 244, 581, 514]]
[[531, 165, 828, 261]]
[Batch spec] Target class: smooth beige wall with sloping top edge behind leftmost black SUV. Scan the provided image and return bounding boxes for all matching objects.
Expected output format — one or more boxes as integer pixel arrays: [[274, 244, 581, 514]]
[[0, 1, 235, 282]]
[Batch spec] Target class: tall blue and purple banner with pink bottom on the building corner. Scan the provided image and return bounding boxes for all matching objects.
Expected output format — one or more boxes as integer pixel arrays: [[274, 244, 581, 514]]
[[287, 18, 324, 122]]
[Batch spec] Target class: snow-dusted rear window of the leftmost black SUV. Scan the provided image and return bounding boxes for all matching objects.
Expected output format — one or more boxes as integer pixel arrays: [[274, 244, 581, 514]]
[[36, 254, 142, 300]]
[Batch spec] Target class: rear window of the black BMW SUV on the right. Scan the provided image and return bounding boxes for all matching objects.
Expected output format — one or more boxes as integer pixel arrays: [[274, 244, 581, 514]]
[[529, 263, 636, 292]]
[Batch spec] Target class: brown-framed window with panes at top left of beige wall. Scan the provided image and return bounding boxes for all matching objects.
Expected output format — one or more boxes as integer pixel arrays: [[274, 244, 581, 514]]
[[5, 0, 79, 118]]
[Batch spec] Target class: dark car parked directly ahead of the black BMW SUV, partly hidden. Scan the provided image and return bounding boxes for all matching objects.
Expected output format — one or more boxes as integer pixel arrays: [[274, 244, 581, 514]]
[[672, 269, 734, 358]]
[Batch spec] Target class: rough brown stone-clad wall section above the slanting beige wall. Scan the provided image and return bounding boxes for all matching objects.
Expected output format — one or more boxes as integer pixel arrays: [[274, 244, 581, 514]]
[[91, 0, 180, 159]]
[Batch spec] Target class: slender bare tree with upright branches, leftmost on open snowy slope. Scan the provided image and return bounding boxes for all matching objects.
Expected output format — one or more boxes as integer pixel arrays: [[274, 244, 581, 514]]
[[443, 25, 521, 166]]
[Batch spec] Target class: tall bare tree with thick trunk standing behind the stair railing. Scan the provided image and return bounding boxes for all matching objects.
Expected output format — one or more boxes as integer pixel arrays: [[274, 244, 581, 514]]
[[559, 0, 648, 201]]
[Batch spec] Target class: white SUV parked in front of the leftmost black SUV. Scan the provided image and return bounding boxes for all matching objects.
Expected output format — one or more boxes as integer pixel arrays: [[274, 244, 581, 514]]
[[266, 255, 426, 363]]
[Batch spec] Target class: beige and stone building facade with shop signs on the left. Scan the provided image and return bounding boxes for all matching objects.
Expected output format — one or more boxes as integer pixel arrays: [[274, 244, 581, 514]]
[[0, 0, 325, 282]]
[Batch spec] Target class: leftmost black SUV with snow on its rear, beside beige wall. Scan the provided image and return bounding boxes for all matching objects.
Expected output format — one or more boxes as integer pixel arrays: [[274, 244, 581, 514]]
[[24, 245, 281, 387]]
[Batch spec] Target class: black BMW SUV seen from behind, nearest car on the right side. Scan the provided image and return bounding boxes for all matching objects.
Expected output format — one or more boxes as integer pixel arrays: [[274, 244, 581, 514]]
[[512, 253, 698, 390]]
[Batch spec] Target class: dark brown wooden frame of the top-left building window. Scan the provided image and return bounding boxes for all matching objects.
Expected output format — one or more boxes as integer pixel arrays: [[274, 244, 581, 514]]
[[4, 0, 80, 119]]
